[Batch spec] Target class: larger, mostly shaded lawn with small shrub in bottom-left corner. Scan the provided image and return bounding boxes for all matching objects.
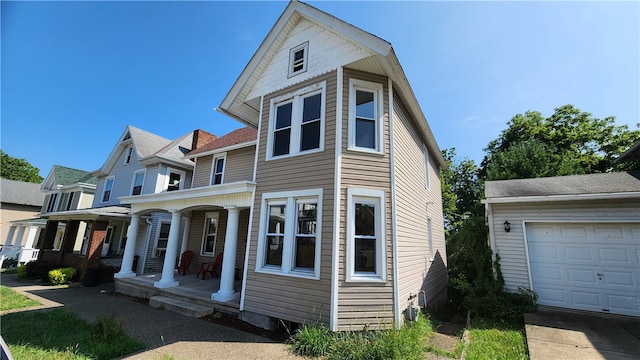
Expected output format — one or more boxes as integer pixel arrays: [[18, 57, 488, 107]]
[[2, 309, 146, 360]]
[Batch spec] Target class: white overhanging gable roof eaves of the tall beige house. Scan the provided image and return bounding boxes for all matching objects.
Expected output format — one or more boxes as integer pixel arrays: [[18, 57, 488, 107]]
[[217, 0, 446, 167]]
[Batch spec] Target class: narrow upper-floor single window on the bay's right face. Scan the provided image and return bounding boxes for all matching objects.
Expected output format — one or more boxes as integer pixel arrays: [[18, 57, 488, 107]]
[[349, 79, 384, 154]]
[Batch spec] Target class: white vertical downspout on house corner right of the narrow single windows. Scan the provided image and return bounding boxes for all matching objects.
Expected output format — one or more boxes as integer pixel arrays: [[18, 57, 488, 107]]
[[387, 79, 401, 329]]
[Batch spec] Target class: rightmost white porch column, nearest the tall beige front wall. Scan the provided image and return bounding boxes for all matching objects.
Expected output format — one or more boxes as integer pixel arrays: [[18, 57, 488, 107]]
[[211, 208, 240, 302]]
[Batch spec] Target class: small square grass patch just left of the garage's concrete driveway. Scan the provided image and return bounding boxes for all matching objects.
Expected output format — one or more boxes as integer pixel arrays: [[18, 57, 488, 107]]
[[466, 318, 529, 360]]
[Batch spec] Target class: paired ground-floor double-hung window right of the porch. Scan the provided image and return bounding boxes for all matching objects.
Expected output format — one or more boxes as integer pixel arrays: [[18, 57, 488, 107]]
[[256, 189, 322, 279]]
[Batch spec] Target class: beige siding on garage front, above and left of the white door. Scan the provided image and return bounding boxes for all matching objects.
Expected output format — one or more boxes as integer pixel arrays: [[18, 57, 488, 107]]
[[491, 199, 640, 291]]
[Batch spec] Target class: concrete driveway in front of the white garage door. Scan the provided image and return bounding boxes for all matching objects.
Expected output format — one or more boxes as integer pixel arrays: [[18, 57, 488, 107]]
[[524, 307, 640, 360]]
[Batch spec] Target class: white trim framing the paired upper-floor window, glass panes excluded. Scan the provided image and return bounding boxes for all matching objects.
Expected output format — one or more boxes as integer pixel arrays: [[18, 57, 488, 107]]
[[265, 81, 327, 161]]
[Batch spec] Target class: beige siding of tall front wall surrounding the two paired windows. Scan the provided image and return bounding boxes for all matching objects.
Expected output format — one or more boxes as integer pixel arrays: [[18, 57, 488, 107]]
[[244, 72, 337, 323]]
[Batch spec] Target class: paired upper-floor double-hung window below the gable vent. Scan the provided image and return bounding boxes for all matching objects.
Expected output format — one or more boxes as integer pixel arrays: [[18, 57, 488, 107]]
[[267, 82, 326, 159]]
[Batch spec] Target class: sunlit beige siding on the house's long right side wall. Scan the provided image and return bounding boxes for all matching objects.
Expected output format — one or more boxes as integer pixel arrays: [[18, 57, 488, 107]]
[[393, 98, 447, 311]]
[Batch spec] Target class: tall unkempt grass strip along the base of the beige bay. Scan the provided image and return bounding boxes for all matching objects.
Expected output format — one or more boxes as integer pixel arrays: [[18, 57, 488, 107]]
[[290, 316, 440, 360]]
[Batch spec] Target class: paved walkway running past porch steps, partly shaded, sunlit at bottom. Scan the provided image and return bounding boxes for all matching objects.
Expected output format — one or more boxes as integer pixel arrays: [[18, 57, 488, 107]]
[[0, 274, 300, 360]]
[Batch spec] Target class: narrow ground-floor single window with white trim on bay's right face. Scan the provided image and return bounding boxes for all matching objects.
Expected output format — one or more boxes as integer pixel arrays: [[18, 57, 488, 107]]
[[346, 188, 387, 282]]
